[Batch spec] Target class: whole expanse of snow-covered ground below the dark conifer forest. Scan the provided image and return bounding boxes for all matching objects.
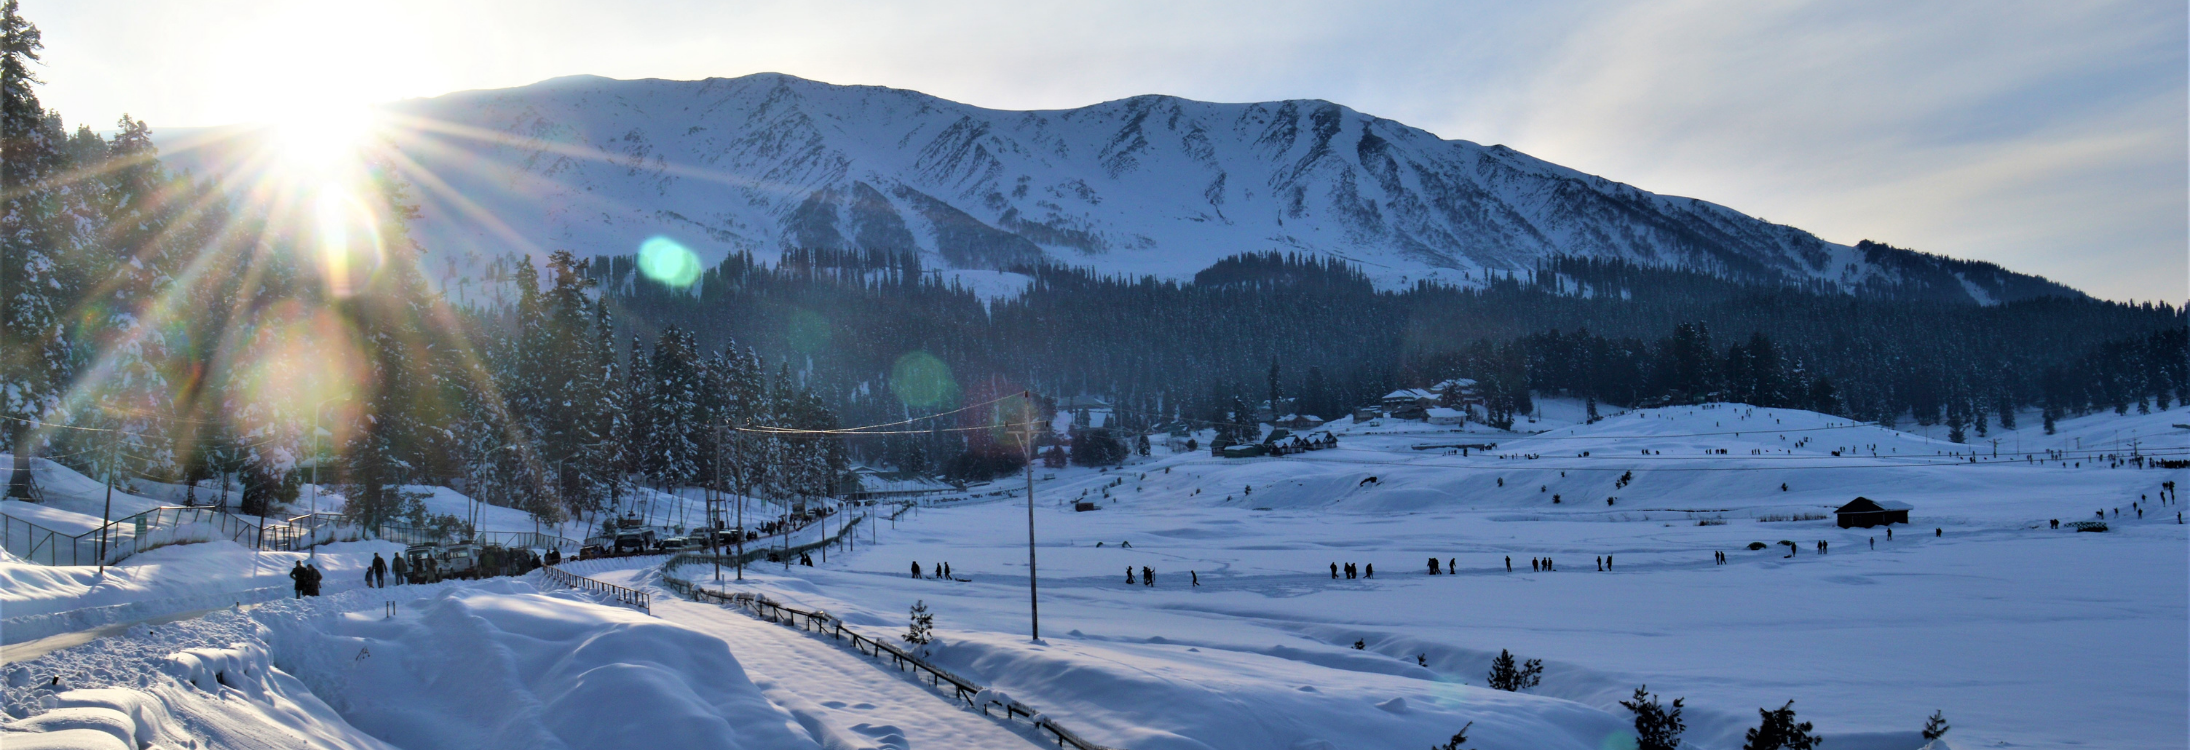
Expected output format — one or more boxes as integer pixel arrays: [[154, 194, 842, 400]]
[[0, 401, 2190, 750]]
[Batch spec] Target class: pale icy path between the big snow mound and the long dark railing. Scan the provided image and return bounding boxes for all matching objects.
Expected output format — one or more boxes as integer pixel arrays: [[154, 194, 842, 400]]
[[591, 570, 1047, 750]]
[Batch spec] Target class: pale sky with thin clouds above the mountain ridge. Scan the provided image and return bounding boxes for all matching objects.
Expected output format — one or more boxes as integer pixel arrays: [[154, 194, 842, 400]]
[[24, 0, 2190, 305]]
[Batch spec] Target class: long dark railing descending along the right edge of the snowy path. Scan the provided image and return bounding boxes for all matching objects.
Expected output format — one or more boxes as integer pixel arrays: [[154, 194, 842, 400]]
[[661, 555, 1113, 750]]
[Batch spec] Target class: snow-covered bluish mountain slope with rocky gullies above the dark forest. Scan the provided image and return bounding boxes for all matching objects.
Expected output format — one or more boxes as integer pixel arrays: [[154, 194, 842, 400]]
[[183, 75, 2076, 303]]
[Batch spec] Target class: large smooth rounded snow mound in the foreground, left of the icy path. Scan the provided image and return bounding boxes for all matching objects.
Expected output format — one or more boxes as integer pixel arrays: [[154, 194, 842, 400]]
[[283, 583, 817, 750]]
